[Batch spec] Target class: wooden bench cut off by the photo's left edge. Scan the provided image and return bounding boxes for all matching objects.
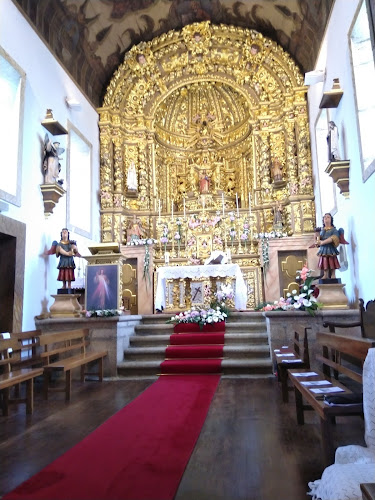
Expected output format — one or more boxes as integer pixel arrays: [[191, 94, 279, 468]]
[[0, 338, 43, 416]]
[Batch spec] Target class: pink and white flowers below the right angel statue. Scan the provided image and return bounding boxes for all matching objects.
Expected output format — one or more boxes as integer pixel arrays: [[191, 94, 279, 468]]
[[255, 264, 322, 316]]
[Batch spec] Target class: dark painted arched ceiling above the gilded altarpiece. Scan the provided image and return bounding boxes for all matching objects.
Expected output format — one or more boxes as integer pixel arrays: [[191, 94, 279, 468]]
[[13, 0, 334, 106]]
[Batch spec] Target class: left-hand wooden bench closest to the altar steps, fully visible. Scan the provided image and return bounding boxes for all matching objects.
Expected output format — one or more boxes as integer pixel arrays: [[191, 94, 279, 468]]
[[40, 329, 108, 401]]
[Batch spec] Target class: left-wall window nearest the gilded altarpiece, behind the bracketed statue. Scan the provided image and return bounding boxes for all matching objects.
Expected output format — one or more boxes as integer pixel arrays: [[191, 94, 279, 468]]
[[67, 124, 92, 238]]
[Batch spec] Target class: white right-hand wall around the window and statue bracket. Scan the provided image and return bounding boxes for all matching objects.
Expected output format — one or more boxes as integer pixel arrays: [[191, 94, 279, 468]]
[[308, 0, 375, 303]]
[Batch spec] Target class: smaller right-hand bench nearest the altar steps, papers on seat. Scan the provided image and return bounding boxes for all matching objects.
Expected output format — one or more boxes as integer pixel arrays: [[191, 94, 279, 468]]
[[274, 327, 310, 403]]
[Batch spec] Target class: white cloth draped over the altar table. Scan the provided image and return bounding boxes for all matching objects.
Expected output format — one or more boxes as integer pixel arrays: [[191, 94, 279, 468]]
[[155, 264, 247, 310]]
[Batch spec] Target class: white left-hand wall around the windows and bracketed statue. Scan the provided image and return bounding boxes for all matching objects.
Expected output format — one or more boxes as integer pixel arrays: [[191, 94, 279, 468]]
[[0, 0, 100, 330]]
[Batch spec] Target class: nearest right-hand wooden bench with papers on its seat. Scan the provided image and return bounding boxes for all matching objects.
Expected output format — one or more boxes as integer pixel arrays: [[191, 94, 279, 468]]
[[288, 333, 375, 466]]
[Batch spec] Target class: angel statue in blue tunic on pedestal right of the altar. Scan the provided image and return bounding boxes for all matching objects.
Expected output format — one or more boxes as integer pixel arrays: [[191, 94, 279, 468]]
[[315, 213, 349, 279]]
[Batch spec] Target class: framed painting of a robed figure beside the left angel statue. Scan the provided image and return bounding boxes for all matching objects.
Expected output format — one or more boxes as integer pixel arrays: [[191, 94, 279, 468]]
[[86, 264, 120, 311]]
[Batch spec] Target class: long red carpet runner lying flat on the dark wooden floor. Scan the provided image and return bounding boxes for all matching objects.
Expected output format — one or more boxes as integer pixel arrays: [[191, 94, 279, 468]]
[[3, 375, 220, 500]]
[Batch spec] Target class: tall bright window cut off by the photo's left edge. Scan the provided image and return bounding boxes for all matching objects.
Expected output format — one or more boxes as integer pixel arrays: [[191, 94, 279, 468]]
[[0, 47, 26, 206]]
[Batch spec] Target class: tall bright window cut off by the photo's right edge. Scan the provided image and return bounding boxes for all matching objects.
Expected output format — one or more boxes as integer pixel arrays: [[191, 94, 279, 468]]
[[350, 1, 375, 181]]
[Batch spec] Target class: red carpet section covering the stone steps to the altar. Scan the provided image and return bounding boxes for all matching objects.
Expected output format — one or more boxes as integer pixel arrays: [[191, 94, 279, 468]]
[[161, 333, 224, 374]]
